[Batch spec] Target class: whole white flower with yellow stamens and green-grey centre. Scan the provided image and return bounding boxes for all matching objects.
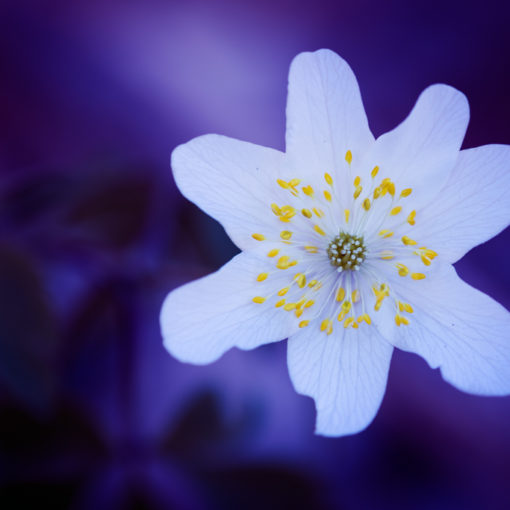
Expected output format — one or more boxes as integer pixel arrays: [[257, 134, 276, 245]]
[[161, 50, 510, 436]]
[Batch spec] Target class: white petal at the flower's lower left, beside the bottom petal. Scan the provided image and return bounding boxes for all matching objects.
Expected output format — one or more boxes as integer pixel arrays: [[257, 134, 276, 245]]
[[160, 253, 298, 364]]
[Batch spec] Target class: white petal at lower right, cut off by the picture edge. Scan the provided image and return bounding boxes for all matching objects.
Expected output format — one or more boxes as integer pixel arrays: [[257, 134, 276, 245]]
[[393, 264, 510, 395]]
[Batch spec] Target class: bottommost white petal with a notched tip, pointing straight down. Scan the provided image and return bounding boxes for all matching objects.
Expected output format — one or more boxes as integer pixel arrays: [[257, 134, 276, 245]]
[[288, 323, 393, 436]]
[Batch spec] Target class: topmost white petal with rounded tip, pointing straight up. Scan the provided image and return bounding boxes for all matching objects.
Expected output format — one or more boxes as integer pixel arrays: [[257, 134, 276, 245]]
[[286, 50, 374, 181]]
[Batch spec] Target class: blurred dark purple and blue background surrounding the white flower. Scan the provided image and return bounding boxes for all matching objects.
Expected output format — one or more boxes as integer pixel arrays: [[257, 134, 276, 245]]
[[0, 0, 510, 510]]
